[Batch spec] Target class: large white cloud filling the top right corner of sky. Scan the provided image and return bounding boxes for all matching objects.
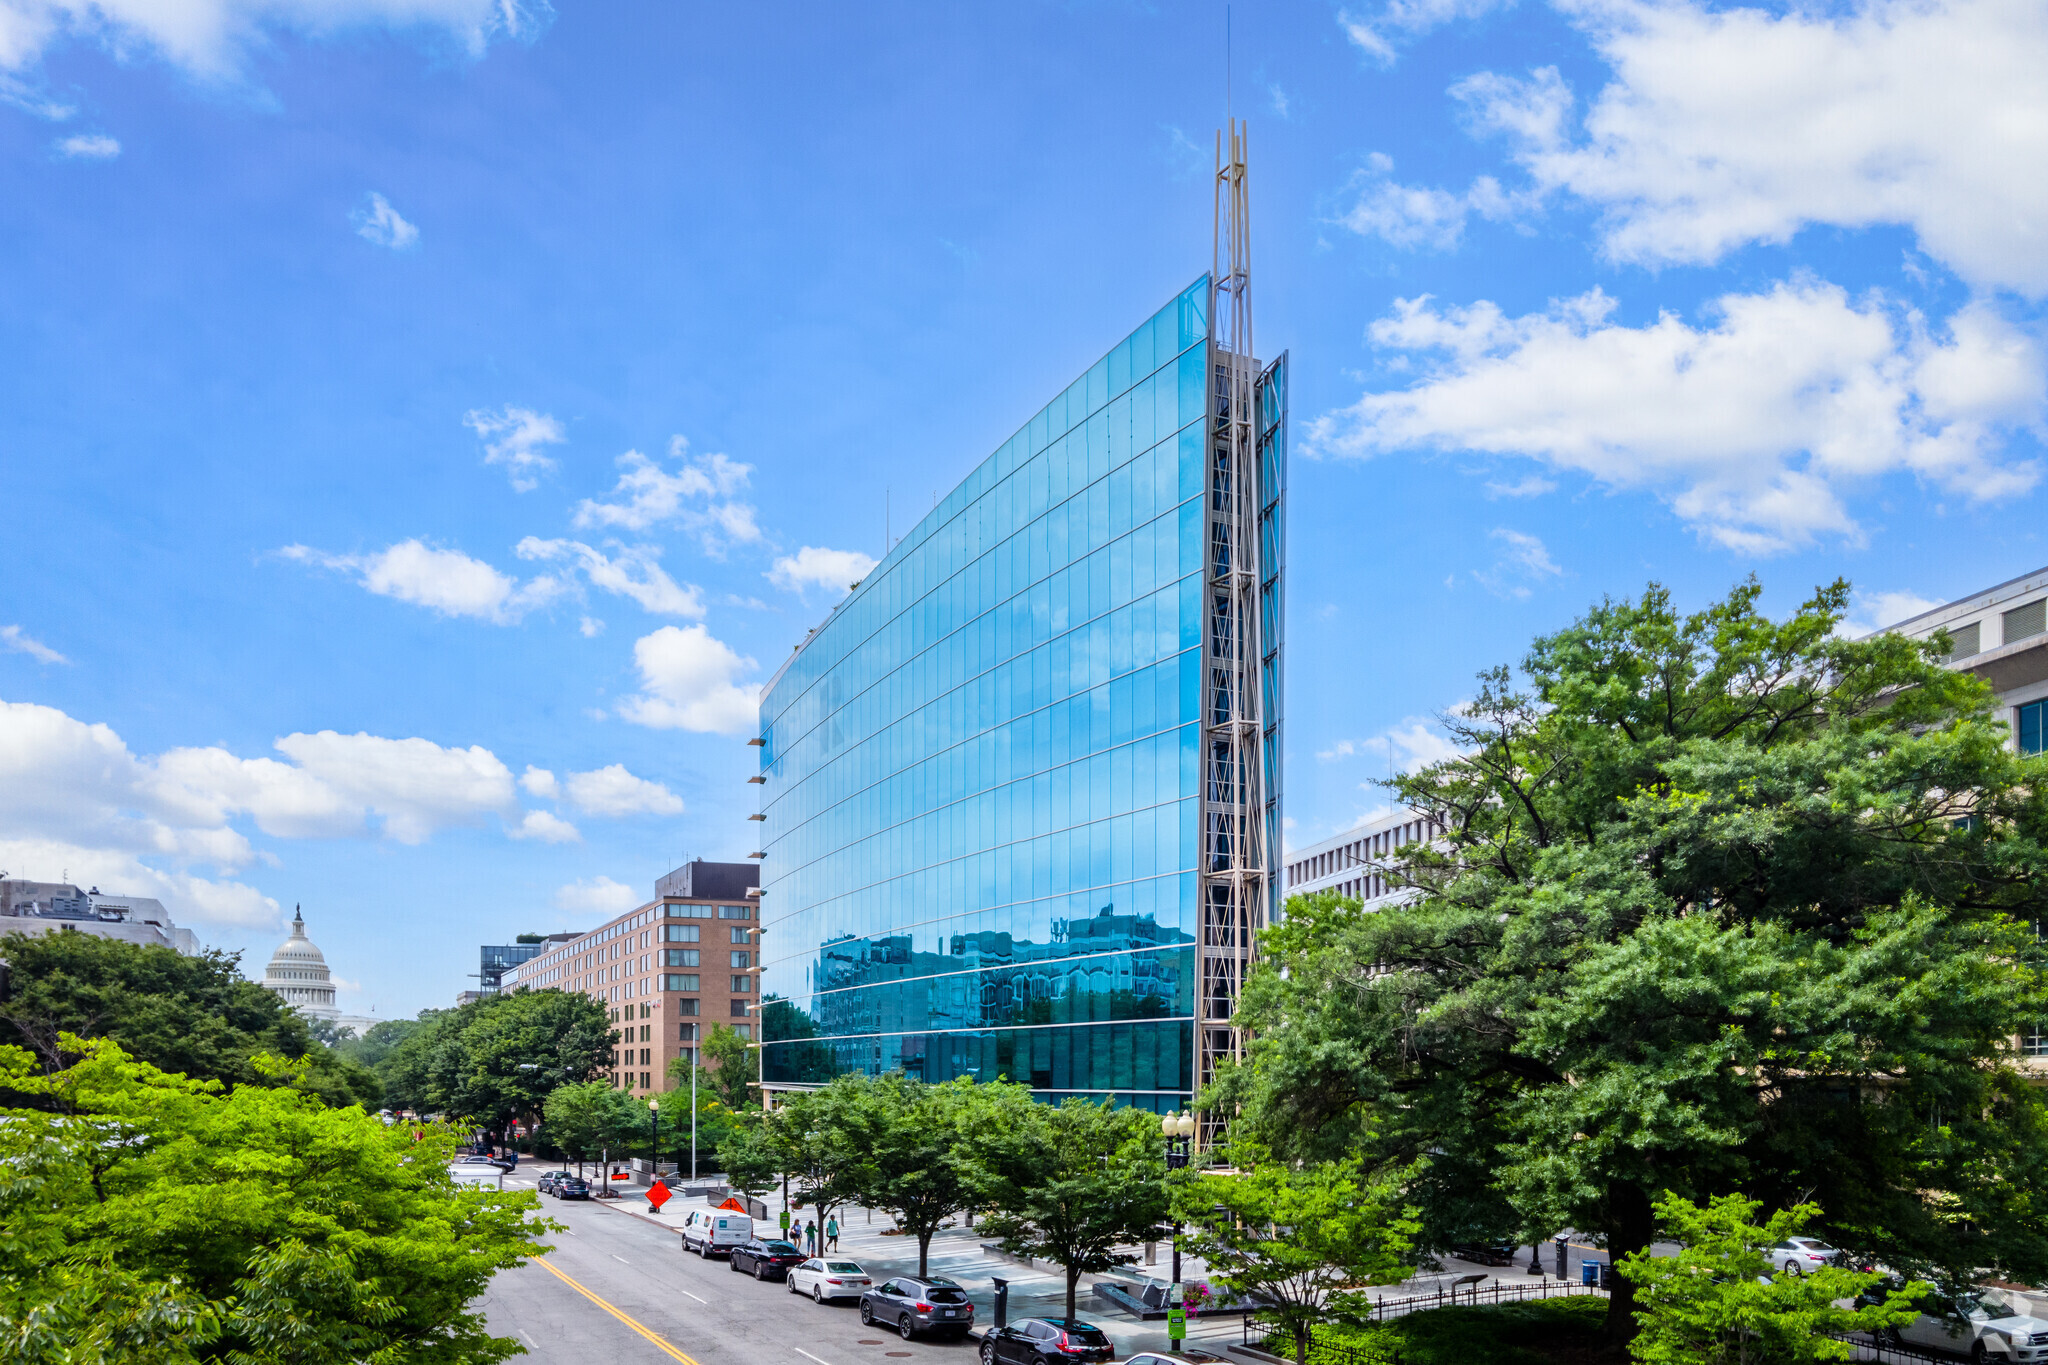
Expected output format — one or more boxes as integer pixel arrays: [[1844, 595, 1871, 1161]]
[[1462, 0, 2048, 297]]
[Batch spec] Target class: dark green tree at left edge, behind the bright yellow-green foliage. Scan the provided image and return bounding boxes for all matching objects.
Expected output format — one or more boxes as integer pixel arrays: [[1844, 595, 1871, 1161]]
[[0, 929, 379, 1109]]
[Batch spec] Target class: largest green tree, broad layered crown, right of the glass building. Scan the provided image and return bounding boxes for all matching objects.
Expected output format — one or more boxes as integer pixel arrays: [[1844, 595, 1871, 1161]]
[[1206, 583, 2048, 1340]]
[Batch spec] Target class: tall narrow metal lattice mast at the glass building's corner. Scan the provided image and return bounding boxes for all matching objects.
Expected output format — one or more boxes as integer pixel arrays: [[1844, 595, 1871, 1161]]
[[1194, 119, 1270, 1146]]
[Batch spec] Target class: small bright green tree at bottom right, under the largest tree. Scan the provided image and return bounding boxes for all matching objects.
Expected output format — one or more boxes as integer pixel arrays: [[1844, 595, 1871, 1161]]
[[1616, 1195, 1933, 1365]]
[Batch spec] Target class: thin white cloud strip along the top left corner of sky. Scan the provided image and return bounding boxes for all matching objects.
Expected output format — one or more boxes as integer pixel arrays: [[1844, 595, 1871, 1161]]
[[0, 0, 553, 80]]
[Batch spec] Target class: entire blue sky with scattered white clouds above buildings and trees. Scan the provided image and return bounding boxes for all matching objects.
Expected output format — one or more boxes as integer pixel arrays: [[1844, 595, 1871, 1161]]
[[0, 0, 2048, 1015]]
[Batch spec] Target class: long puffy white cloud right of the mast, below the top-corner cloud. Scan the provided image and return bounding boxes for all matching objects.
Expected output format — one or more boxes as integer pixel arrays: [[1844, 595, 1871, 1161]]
[[1309, 280, 2044, 555]]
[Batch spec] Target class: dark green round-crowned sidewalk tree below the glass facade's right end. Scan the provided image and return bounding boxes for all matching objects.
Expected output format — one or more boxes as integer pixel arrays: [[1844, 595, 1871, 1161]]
[[963, 1087, 1167, 1318]]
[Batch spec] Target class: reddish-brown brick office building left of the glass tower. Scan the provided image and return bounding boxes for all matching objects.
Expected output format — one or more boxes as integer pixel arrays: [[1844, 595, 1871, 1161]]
[[502, 860, 760, 1093]]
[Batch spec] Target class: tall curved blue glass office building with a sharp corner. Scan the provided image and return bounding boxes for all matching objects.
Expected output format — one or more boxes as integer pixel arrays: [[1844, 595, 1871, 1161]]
[[756, 276, 1286, 1111]]
